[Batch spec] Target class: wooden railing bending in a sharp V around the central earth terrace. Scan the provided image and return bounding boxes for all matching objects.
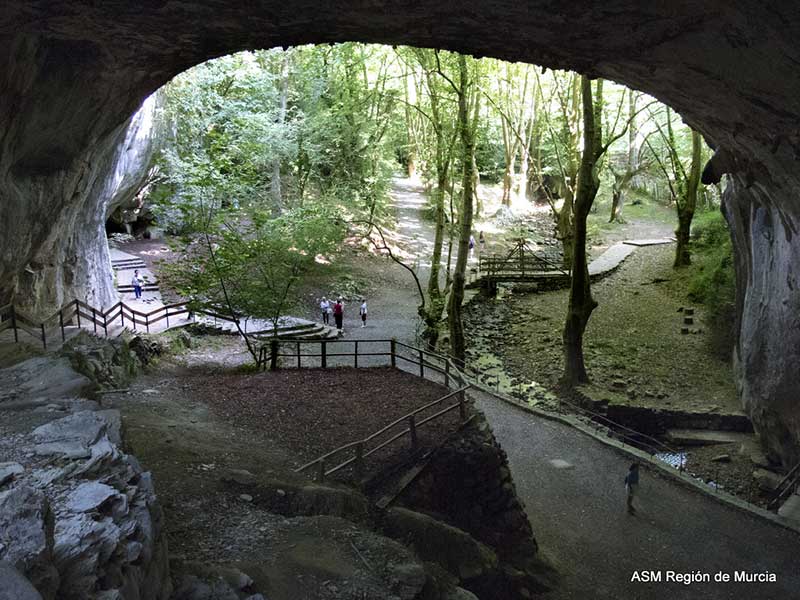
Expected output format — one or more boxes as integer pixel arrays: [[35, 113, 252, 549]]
[[272, 339, 471, 481]]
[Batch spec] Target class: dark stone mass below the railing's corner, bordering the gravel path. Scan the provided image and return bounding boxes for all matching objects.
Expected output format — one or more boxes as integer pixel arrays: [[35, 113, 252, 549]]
[[396, 413, 553, 598]]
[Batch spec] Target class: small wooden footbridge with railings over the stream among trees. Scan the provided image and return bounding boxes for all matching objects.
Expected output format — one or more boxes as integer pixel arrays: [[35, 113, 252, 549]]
[[466, 240, 570, 294]]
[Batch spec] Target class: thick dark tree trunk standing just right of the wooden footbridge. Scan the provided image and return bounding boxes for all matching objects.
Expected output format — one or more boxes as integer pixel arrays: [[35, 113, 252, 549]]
[[562, 75, 602, 386]]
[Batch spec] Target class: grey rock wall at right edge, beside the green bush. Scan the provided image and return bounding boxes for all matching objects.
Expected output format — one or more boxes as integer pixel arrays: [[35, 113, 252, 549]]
[[725, 174, 800, 466]]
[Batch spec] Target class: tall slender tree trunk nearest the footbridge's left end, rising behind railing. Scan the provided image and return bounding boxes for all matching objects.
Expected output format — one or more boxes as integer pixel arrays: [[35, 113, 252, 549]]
[[447, 55, 478, 364]]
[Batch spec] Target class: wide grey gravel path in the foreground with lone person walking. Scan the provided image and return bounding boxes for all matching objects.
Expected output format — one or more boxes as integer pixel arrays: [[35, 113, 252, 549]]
[[472, 392, 800, 600]]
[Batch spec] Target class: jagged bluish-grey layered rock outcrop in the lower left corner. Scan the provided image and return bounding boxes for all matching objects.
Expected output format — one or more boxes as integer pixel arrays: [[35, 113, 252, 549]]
[[0, 350, 170, 600]]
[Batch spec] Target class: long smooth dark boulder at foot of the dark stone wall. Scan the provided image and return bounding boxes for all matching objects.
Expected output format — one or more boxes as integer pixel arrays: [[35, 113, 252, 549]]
[[384, 508, 498, 581]]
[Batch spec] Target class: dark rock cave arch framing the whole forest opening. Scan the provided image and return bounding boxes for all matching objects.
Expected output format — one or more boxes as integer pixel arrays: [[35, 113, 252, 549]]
[[0, 0, 800, 462]]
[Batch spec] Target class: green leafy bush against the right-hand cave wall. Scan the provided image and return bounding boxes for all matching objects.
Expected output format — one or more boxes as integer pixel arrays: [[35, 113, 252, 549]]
[[689, 211, 736, 360]]
